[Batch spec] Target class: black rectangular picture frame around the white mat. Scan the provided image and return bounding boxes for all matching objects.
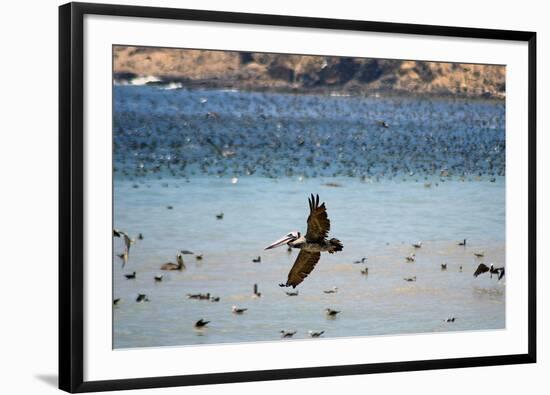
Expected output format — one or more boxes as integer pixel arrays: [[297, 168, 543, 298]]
[[59, 3, 537, 392]]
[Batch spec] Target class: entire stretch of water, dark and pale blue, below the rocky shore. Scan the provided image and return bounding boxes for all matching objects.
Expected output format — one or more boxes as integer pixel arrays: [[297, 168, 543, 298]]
[[113, 87, 505, 348]]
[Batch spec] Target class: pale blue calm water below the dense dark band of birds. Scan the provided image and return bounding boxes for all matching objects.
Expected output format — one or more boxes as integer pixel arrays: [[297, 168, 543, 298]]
[[113, 177, 505, 347]]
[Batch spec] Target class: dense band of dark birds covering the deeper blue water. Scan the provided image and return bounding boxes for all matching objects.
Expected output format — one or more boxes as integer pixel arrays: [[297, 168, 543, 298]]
[[114, 86, 505, 183]]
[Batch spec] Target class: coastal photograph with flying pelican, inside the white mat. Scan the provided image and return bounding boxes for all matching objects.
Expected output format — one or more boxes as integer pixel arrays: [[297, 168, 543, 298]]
[[113, 43, 508, 350]]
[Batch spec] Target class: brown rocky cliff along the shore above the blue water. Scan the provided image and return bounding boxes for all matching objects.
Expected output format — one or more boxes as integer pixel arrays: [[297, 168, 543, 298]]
[[113, 46, 506, 98]]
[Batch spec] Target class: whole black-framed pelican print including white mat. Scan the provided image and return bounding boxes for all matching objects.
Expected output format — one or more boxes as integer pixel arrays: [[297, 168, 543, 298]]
[[59, 3, 536, 392]]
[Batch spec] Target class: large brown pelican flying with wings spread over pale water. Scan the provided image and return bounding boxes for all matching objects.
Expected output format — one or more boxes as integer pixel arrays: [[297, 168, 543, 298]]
[[265, 194, 344, 288]]
